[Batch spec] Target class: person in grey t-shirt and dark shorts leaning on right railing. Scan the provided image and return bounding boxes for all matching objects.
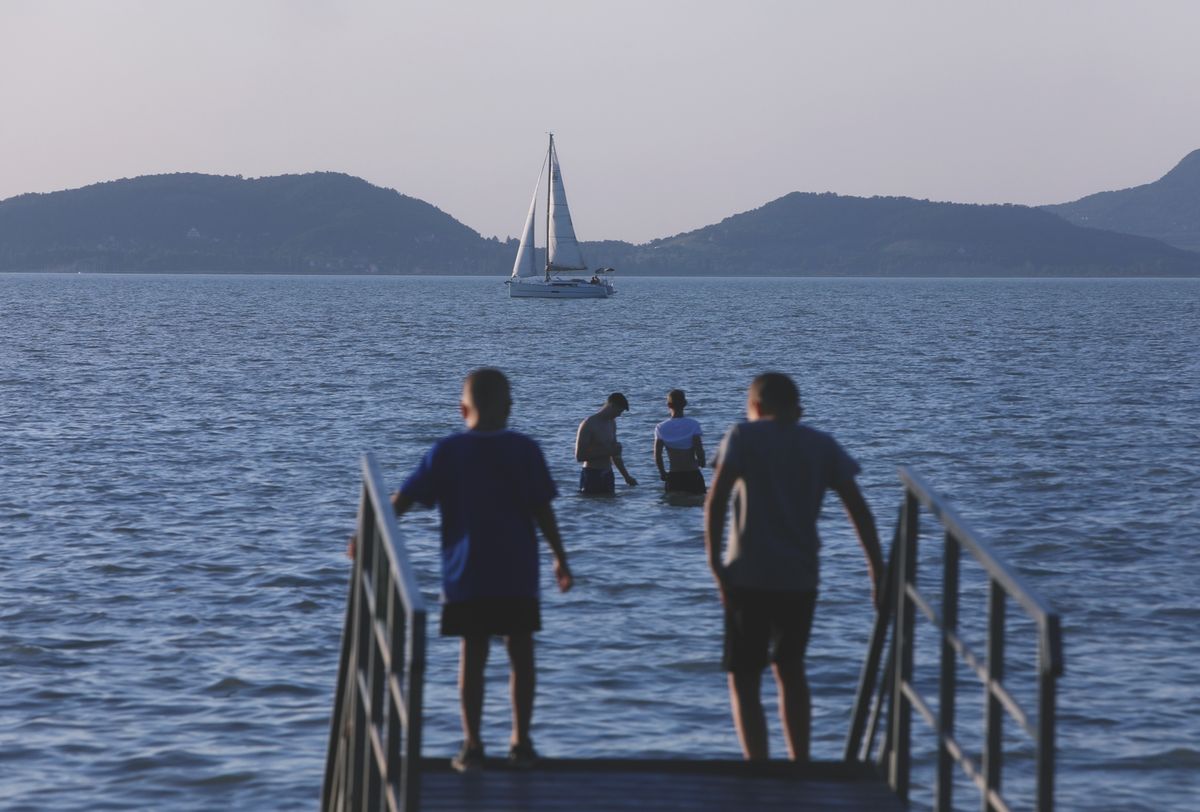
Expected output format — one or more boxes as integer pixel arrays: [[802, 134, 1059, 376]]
[[704, 372, 883, 760]]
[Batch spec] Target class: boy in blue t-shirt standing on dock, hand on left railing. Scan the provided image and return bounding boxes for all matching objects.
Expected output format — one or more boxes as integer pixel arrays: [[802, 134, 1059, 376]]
[[391, 368, 572, 772]]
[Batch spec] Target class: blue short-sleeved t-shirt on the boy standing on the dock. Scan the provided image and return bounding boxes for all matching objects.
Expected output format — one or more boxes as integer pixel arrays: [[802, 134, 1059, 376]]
[[400, 429, 558, 603]]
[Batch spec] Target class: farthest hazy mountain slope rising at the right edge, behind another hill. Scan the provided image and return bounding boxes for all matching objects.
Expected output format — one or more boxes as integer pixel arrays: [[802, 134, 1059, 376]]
[[1043, 150, 1200, 251]]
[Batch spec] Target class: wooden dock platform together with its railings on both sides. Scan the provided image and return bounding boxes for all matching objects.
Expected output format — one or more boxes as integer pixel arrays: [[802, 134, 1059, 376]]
[[322, 455, 1063, 812]]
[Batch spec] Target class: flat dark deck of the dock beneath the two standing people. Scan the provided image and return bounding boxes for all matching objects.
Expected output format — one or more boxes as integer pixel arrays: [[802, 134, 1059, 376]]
[[421, 758, 907, 812]]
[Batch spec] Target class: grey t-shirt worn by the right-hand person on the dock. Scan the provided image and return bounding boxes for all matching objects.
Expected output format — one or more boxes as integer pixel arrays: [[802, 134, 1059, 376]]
[[716, 420, 860, 590]]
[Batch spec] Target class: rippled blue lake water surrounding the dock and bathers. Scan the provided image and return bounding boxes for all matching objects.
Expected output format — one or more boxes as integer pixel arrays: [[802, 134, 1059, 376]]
[[0, 275, 1200, 811]]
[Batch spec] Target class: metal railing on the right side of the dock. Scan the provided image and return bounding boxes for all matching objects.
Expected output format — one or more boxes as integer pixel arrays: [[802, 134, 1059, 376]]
[[845, 468, 1063, 812]]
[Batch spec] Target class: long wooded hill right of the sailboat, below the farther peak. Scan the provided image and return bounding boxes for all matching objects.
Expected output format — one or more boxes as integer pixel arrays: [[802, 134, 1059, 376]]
[[589, 192, 1200, 276]]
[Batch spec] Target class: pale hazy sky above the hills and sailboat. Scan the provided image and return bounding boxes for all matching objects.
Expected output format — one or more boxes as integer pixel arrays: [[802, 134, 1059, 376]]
[[0, 0, 1200, 241]]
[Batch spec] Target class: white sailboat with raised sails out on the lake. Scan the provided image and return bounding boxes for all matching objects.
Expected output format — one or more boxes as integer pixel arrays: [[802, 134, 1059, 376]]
[[508, 133, 617, 299]]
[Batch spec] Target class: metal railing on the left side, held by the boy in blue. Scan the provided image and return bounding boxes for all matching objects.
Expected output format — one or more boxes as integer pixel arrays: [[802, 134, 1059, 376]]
[[320, 453, 425, 812]]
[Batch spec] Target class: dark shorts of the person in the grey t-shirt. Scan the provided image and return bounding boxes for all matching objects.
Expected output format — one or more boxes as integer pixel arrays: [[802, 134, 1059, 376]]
[[721, 587, 817, 674]]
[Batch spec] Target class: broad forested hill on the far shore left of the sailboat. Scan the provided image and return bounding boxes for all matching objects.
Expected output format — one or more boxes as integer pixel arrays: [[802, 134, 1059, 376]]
[[0, 173, 515, 273]]
